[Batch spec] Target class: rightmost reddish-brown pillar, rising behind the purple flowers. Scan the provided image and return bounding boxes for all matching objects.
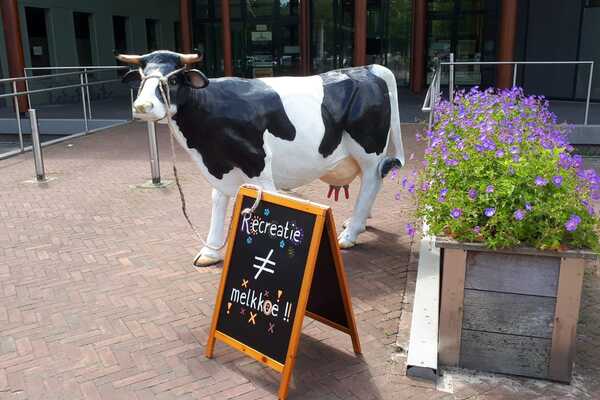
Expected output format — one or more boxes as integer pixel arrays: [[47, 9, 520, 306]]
[[496, 0, 518, 88]]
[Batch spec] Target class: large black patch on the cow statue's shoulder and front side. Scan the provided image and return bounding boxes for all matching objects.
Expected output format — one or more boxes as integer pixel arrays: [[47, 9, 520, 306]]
[[174, 78, 296, 179]]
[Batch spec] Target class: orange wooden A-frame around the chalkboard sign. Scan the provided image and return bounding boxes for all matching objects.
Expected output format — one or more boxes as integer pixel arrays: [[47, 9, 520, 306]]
[[205, 187, 361, 400]]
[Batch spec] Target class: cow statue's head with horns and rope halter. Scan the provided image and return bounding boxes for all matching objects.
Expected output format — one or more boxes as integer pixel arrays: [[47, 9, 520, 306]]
[[116, 50, 208, 121]]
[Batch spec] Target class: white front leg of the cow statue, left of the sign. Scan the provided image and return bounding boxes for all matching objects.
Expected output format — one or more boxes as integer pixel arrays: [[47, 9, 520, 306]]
[[194, 189, 229, 267]]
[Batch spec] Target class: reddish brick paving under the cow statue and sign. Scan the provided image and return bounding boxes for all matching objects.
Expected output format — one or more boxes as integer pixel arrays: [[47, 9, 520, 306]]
[[0, 124, 600, 400]]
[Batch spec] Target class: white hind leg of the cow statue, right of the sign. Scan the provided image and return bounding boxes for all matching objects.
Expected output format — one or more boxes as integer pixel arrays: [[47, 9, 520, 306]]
[[338, 168, 381, 249]]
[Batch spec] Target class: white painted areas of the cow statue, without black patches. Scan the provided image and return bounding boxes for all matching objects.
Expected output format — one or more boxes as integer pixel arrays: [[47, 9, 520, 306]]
[[122, 51, 404, 265]]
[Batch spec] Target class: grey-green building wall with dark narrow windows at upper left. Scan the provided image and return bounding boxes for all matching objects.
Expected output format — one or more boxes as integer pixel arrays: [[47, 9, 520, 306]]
[[0, 0, 179, 77]]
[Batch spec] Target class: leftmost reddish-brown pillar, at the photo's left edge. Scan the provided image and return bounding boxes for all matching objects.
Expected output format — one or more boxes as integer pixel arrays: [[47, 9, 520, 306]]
[[0, 0, 29, 112]]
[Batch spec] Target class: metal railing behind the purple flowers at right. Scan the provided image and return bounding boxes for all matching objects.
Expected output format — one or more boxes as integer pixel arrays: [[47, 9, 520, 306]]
[[421, 53, 594, 128]]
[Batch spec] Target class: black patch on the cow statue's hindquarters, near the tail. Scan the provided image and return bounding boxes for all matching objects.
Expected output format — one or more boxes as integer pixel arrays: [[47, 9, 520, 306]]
[[319, 67, 391, 157]]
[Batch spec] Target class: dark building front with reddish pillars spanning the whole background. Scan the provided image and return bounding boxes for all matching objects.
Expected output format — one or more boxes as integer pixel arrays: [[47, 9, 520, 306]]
[[0, 0, 600, 100]]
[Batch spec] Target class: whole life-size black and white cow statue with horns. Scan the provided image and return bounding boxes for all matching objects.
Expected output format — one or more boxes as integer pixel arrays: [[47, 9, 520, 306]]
[[117, 51, 404, 266]]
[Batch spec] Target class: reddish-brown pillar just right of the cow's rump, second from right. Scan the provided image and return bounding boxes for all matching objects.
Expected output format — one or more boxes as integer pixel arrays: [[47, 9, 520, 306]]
[[410, 0, 427, 93]]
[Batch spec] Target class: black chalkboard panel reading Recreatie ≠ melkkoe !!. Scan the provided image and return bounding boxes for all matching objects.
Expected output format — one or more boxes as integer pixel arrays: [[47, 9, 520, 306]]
[[217, 197, 316, 364]]
